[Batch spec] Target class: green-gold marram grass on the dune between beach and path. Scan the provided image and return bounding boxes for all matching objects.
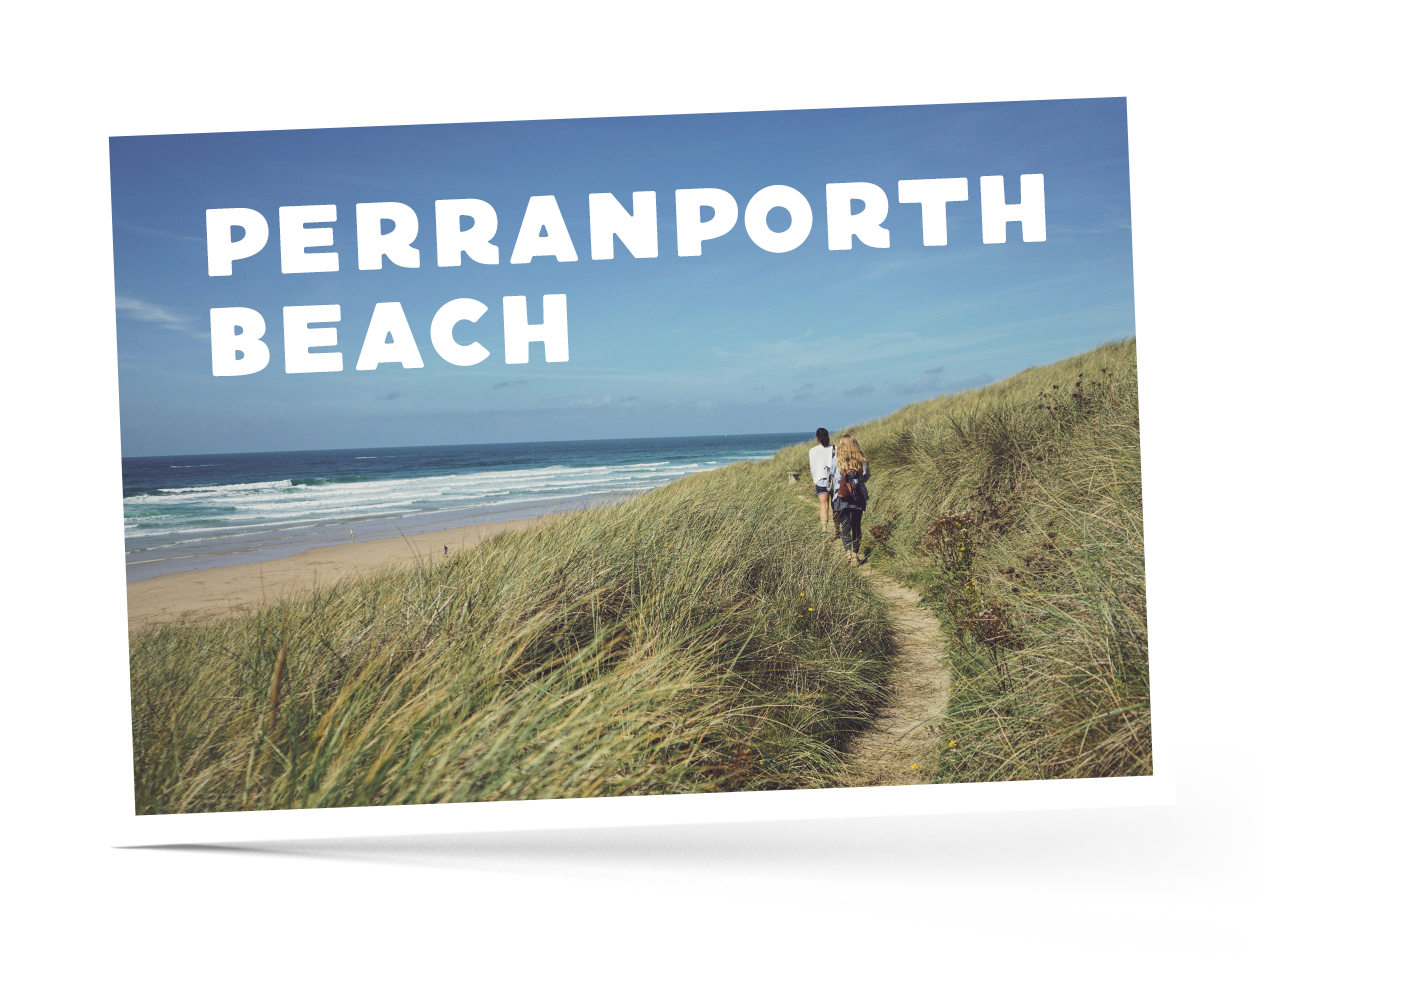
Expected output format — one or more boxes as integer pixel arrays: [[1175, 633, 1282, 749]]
[[131, 463, 889, 813]]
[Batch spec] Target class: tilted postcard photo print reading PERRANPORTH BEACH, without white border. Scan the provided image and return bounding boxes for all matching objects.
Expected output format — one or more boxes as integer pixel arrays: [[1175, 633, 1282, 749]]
[[110, 97, 1154, 814]]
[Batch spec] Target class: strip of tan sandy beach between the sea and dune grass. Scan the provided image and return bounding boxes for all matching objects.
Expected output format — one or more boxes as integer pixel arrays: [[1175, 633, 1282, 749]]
[[127, 514, 562, 631]]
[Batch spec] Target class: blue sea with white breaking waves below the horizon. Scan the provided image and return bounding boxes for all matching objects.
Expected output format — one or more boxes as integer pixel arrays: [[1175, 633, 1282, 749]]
[[123, 434, 807, 582]]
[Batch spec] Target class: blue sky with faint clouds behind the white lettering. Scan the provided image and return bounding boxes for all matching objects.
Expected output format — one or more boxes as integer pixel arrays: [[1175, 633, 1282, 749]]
[[111, 99, 1134, 455]]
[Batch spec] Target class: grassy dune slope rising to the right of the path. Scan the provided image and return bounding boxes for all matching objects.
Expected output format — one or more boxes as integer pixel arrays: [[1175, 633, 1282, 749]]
[[779, 339, 1154, 782]]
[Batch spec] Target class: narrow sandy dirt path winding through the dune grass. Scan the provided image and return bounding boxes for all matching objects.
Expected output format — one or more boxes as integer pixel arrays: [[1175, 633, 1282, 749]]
[[847, 566, 950, 786]]
